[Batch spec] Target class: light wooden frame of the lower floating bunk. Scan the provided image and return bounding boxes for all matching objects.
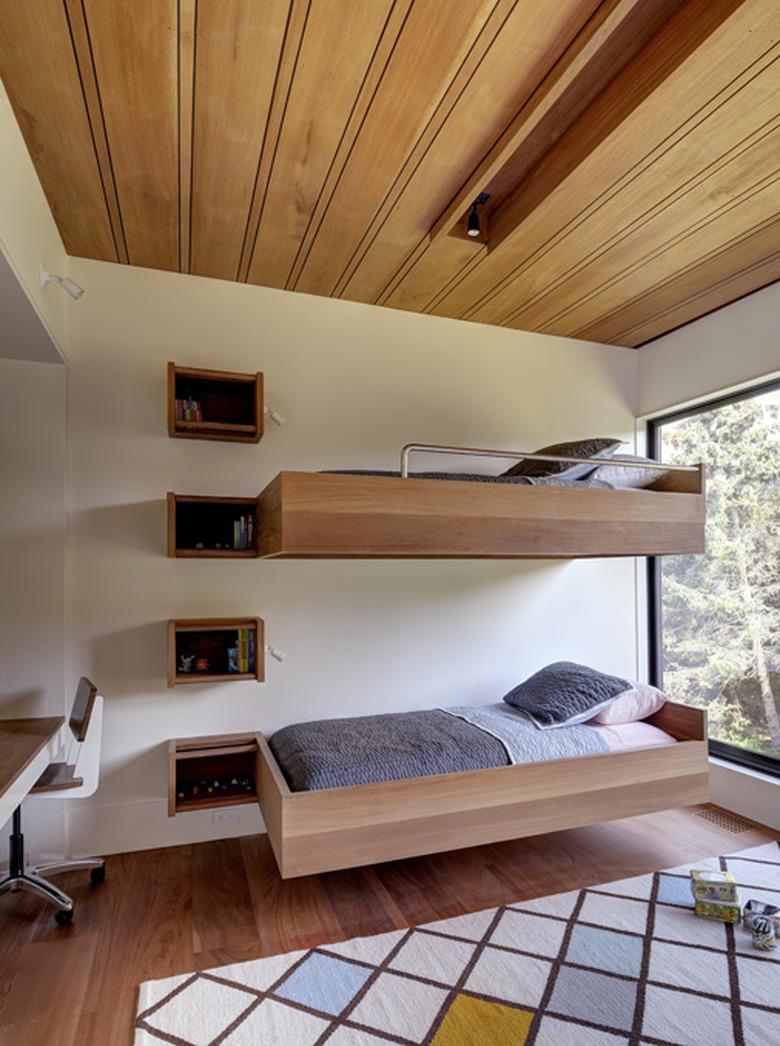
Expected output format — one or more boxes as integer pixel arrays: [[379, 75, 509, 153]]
[[256, 703, 709, 879]]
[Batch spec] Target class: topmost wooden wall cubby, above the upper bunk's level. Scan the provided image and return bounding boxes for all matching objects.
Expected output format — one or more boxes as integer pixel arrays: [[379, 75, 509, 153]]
[[168, 363, 263, 444]]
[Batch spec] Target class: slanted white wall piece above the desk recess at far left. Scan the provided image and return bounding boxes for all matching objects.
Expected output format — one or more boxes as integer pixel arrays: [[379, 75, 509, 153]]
[[0, 82, 68, 356]]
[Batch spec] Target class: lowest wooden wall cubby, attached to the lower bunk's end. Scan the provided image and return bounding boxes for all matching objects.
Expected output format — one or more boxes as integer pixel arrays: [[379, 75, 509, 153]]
[[168, 733, 258, 817]]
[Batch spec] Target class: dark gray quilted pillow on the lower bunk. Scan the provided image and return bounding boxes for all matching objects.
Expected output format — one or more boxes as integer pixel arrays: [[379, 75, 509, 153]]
[[504, 661, 632, 730]]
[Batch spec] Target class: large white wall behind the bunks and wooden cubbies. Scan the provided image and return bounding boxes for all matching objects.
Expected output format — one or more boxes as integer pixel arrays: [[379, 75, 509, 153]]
[[63, 259, 638, 852]]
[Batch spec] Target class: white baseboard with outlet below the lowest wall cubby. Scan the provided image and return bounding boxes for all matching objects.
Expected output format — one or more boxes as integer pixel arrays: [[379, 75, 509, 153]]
[[67, 799, 266, 857]]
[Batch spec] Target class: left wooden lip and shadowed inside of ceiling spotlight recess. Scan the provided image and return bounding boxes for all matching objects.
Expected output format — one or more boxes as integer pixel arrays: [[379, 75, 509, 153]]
[[431, 0, 682, 242]]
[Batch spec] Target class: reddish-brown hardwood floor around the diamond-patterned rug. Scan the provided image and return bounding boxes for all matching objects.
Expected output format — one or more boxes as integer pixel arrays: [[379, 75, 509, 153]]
[[0, 808, 780, 1046]]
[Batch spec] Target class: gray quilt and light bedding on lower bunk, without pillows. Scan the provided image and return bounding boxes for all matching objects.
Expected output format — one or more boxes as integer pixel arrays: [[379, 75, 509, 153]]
[[269, 706, 675, 792]]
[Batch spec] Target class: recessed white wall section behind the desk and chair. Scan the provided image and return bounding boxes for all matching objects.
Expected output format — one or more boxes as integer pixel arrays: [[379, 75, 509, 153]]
[[0, 360, 66, 860]]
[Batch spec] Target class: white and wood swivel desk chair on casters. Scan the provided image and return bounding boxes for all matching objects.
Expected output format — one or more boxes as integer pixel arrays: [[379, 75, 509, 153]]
[[0, 676, 106, 926]]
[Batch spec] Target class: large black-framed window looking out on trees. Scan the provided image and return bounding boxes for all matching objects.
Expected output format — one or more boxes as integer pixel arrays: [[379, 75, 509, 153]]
[[648, 383, 780, 776]]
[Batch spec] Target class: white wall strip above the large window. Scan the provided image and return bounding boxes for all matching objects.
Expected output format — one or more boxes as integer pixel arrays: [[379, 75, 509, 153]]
[[638, 282, 780, 415]]
